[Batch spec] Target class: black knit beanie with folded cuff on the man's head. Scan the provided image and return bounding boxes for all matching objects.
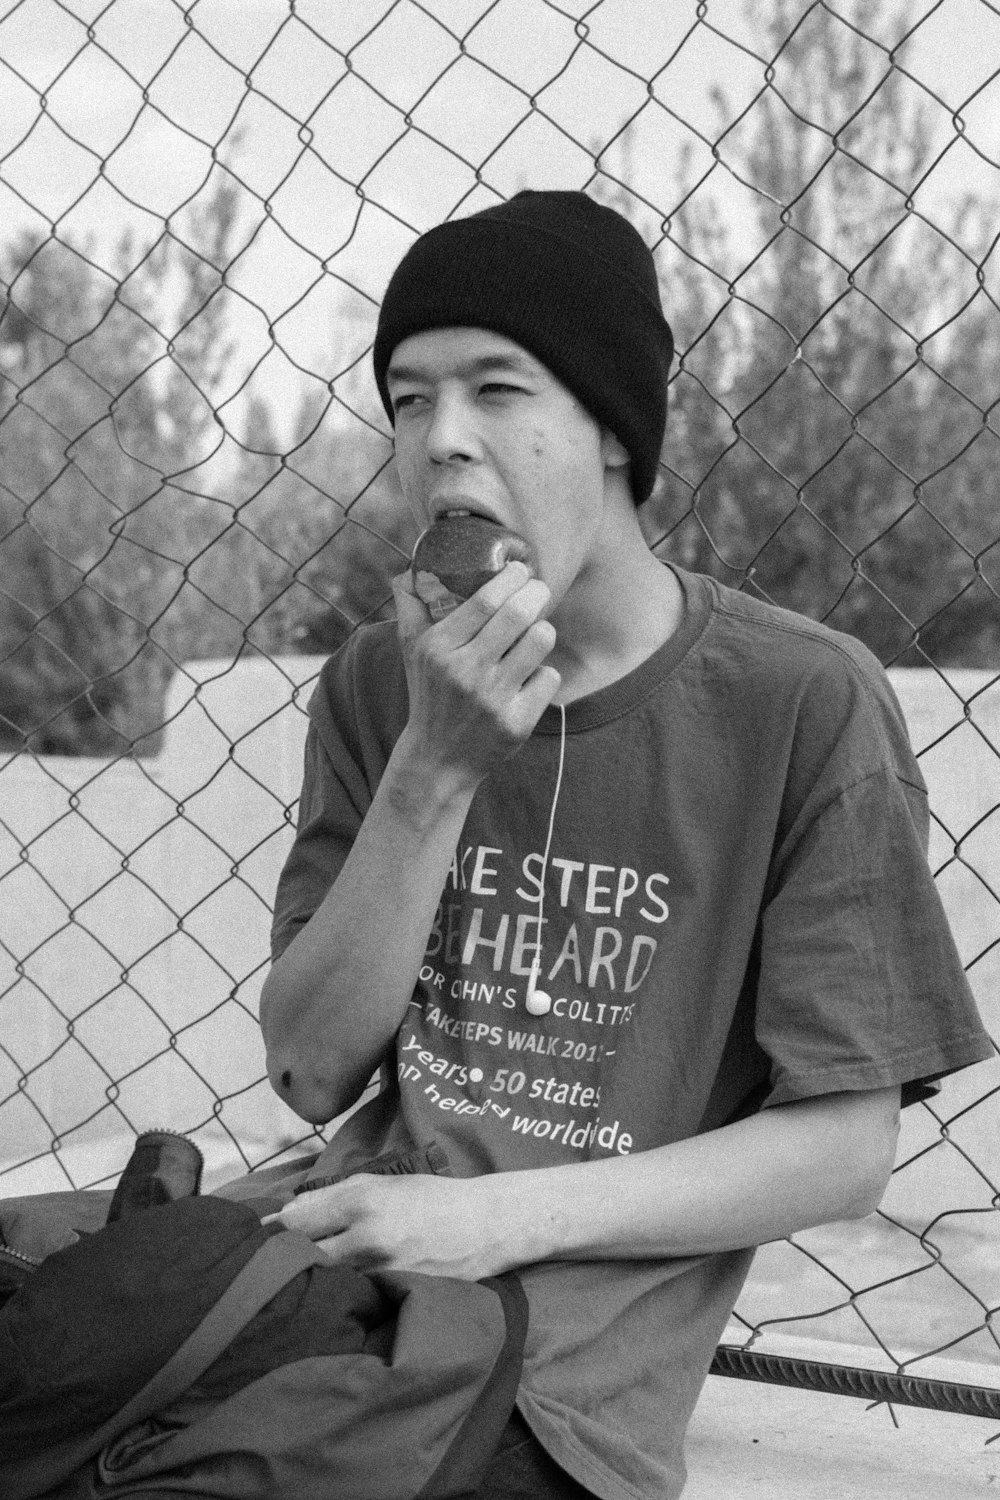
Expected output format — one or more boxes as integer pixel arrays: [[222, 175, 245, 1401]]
[[373, 192, 673, 506]]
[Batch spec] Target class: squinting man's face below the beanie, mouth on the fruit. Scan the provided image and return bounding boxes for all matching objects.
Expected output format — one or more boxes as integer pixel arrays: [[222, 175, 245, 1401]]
[[387, 329, 625, 602]]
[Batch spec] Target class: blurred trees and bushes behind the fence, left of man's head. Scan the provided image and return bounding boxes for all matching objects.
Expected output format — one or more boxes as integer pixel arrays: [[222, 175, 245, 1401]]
[[0, 177, 412, 755]]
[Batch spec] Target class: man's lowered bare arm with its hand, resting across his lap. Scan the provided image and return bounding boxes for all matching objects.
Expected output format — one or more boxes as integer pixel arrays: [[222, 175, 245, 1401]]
[[269, 1089, 900, 1281]]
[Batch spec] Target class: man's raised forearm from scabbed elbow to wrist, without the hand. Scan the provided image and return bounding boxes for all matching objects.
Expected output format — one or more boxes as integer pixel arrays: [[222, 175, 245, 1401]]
[[261, 726, 472, 1124]]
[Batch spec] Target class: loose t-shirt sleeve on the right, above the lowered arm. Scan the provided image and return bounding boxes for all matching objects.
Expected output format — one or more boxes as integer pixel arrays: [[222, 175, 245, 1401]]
[[756, 654, 993, 1104]]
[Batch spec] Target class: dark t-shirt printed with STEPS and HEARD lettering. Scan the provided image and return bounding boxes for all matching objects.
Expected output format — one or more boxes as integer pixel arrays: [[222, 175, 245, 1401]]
[[274, 570, 993, 1500]]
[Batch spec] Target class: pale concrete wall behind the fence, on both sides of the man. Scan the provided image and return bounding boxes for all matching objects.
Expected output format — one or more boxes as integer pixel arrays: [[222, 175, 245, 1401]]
[[0, 657, 1000, 1361]]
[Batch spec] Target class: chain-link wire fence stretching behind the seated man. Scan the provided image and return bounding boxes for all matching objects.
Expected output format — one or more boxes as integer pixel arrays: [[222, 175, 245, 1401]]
[[0, 0, 1000, 1428]]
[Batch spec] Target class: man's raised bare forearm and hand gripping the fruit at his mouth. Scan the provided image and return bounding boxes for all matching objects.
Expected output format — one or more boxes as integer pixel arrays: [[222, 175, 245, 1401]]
[[261, 563, 559, 1124]]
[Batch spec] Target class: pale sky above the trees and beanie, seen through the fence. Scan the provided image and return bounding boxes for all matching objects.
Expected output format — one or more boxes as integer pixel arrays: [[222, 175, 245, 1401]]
[[0, 0, 1000, 435]]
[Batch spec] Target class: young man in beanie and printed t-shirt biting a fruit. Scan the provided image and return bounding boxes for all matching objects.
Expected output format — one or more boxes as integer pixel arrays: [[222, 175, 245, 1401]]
[[261, 192, 991, 1500]]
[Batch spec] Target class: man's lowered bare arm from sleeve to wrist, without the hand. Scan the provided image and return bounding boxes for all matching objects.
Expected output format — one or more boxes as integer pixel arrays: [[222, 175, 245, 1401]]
[[472, 1089, 900, 1263]]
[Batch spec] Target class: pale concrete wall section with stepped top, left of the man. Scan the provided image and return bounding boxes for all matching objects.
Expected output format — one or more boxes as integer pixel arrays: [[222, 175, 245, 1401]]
[[0, 657, 322, 1193]]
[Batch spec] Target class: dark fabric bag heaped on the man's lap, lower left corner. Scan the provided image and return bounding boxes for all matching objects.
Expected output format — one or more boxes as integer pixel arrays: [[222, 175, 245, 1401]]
[[0, 1136, 528, 1500]]
